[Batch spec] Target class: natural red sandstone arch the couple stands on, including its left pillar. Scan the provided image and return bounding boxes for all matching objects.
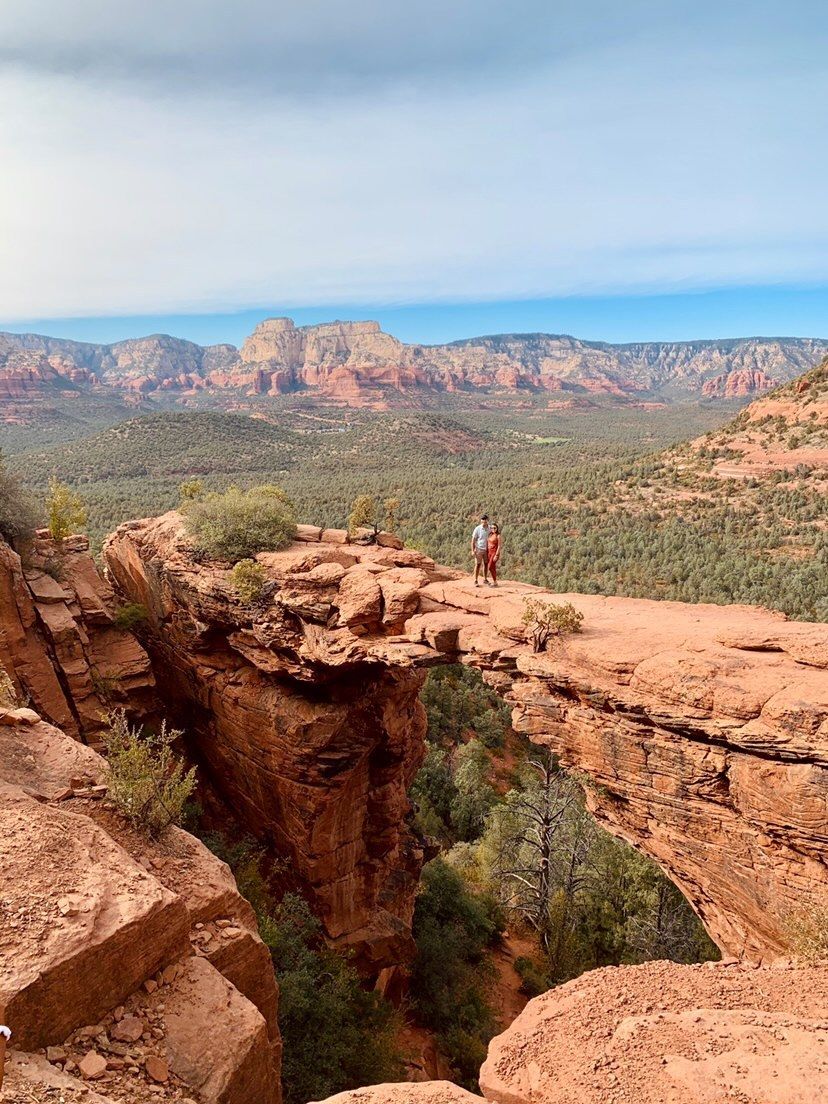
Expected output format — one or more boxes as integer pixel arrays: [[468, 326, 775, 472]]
[[104, 513, 828, 967]]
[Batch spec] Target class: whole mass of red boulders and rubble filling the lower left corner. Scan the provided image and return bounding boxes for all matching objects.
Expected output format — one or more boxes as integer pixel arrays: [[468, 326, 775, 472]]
[[0, 709, 280, 1104]]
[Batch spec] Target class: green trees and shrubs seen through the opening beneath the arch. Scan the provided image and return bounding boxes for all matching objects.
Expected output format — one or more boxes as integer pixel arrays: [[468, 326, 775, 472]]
[[412, 667, 719, 1089]]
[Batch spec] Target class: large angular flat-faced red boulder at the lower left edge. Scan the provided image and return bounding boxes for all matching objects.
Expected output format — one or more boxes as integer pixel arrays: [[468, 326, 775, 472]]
[[0, 785, 189, 1048]]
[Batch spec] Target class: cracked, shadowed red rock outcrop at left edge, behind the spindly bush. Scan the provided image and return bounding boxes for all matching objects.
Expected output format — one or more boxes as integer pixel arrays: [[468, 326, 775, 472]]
[[0, 530, 157, 741]]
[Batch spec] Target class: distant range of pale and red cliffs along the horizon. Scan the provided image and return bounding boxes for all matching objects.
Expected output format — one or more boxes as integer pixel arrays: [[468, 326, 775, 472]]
[[0, 318, 828, 421]]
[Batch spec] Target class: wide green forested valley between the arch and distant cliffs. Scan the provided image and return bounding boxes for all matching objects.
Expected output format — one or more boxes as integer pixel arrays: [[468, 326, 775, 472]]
[[0, 397, 828, 620]]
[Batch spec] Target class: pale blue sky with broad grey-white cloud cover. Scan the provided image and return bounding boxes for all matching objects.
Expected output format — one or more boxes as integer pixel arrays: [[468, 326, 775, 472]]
[[0, 0, 828, 339]]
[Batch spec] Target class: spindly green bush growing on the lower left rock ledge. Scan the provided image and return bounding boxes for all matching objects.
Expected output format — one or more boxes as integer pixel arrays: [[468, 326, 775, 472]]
[[105, 709, 195, 837]]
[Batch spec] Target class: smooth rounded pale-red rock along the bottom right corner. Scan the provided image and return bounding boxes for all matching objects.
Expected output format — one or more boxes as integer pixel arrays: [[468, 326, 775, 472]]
[[315, 962, 828, 1104]]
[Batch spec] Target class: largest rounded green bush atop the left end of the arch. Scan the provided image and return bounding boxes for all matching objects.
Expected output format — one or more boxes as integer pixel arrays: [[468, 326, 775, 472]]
[[182, 484, 296, 563]]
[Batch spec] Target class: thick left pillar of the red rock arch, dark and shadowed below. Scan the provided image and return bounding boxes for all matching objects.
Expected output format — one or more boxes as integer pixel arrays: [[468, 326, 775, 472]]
[[106, 514, 450, 974]]
